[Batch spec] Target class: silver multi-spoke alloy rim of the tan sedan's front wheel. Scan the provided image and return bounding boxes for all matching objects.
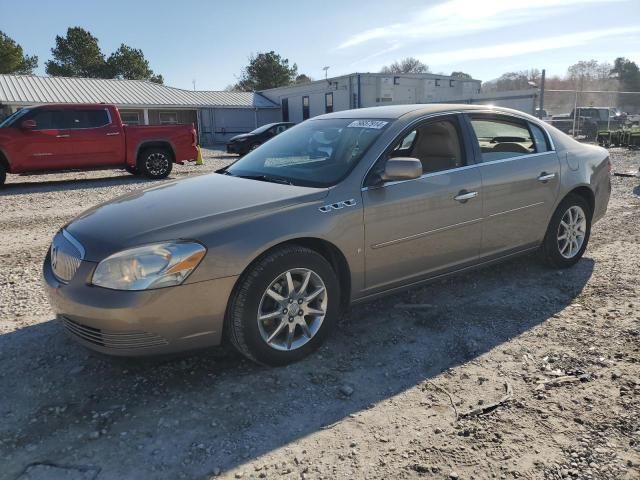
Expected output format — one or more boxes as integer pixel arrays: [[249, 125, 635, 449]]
[[257, 268, 328, 351]]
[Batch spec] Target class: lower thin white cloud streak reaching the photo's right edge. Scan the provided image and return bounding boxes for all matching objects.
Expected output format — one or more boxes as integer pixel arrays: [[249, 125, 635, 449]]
[[417, 26, 640, 64]]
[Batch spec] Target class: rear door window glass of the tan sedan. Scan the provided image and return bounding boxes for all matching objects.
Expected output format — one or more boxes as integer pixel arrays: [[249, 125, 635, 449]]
[[471, 116, 536, 162]]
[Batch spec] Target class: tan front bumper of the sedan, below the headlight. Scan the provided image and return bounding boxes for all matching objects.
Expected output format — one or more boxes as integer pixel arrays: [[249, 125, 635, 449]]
[[43, 254, 238, 356]]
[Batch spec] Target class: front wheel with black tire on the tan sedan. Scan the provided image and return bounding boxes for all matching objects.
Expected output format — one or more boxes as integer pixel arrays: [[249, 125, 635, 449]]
[[225, 245, 340, 366]]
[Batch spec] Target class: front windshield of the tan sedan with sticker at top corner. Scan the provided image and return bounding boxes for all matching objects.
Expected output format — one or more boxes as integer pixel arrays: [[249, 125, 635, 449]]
[[222, 118, 389, 187]]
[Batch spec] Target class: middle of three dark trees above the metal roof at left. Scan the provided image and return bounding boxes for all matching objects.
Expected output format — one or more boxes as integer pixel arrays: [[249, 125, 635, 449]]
[[46, 27, 108, 78]]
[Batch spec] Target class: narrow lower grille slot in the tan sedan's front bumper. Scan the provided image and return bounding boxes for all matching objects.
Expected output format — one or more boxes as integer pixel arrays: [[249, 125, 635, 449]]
[[61, 317, 168, 350]]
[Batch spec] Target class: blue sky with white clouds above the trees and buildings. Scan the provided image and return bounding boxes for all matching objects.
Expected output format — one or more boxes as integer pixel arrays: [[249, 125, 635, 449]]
[[0, 0, 640, 90]]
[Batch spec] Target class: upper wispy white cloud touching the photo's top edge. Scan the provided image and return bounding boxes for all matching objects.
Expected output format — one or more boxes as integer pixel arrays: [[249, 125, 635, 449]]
[[338, 0, 619, 49]]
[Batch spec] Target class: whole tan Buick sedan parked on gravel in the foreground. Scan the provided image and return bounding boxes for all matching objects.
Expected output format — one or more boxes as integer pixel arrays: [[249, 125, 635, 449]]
[[44, 105, 611, 365]]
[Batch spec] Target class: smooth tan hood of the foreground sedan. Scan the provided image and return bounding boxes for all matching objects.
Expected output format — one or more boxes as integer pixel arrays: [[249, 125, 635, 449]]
[[65, 173, 328, 262]]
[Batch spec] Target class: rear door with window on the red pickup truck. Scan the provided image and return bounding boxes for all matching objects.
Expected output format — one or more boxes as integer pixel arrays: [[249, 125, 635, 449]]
[[66, 107, 124, 168]]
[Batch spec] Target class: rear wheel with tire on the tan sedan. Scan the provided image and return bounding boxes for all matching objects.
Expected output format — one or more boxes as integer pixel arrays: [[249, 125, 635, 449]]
[[540, 194, 593, 268]]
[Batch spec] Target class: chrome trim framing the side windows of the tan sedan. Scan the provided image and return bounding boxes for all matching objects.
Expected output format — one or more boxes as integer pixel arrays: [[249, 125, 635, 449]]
[[360, 109, 556, 192]]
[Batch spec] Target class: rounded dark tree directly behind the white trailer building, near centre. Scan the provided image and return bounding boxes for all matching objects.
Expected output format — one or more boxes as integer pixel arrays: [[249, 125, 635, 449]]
[[236, 50, 298, 92]]
